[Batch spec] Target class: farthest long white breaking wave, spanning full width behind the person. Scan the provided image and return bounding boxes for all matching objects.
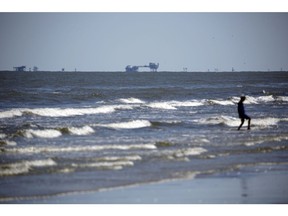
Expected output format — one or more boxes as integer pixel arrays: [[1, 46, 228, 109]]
[[0, 95, 288, 119]]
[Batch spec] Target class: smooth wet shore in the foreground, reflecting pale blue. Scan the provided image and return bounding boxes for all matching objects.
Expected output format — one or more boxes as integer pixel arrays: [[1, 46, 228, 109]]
[[4, 171, 288, 204]]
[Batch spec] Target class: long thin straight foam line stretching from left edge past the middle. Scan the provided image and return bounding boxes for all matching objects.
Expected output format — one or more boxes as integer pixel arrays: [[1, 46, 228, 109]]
[[5, 144, 157, 154]]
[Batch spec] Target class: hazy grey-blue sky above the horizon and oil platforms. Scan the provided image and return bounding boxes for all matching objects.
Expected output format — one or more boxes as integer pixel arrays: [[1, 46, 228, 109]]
[[0, 13, 288, 71]]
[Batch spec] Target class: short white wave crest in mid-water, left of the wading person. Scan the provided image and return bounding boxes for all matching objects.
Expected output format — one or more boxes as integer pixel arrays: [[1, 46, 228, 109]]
[[98, 120, 152, 129]]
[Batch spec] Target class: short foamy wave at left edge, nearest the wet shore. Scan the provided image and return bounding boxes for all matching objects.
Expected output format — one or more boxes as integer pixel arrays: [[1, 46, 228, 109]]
[[0, 158, 57, 176]]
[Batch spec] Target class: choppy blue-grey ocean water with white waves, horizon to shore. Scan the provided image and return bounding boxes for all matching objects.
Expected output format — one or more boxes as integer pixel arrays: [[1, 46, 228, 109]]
[[0, 71, 288, 203]]
